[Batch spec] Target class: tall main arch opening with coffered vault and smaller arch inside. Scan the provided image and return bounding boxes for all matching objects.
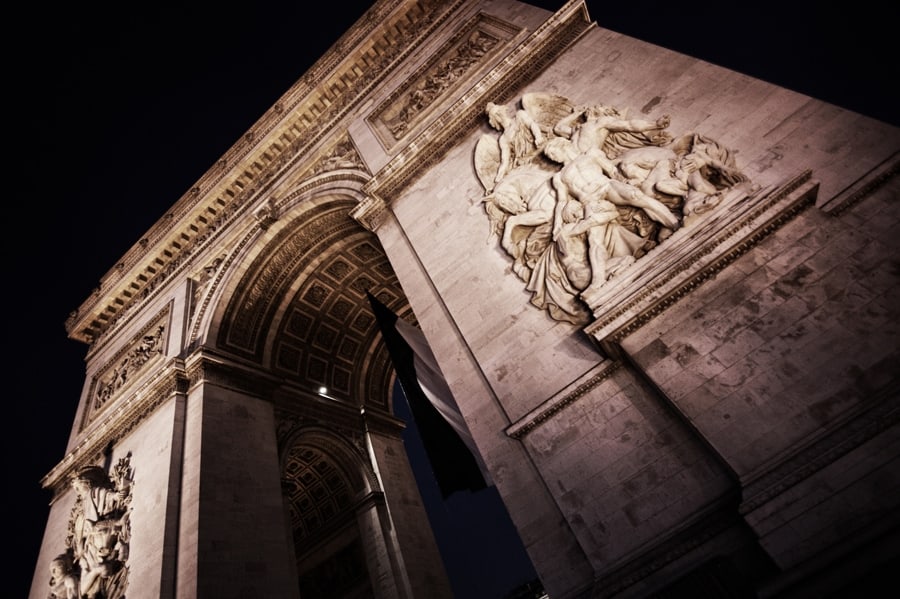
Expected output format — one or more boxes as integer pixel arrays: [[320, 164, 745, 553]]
[[195, 183, 454, 598]]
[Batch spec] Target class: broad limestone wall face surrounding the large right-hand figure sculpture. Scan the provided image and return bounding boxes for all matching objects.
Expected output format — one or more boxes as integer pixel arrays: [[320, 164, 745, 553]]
[[358, 2, 900, 596]]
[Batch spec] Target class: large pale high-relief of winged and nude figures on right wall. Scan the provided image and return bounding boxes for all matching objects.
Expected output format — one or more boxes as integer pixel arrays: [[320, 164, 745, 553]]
[[474, 93, 751, 324]]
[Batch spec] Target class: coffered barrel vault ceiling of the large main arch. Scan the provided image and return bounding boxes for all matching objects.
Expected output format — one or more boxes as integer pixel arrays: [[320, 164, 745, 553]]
[[200, 176, 409, 411]]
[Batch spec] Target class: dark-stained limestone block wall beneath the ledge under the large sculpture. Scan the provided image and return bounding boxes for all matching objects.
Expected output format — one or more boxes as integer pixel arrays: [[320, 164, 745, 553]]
[[623, 177, 900, 567]]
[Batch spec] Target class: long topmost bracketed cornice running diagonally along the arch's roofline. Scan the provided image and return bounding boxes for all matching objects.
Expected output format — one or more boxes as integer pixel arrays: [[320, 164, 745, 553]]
[[66, 0, 464, 346]]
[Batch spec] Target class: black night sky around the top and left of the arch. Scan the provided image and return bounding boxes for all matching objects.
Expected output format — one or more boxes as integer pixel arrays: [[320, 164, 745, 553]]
[[10, 0, 900, 599]]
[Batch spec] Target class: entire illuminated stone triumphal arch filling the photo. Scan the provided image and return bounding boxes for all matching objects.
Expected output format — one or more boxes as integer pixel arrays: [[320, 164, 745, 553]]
[[31, 0, 900, 599]]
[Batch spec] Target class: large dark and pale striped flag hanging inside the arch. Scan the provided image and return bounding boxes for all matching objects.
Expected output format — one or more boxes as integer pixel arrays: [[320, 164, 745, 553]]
[[366, 291, 493, 499]]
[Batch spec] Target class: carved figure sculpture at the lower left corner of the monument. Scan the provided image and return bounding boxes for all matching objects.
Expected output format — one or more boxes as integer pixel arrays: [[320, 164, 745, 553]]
[[49, 454, 134, 599]]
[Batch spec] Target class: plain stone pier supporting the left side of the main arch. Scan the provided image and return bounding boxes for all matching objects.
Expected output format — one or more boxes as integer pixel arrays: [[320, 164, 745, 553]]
[[178, 360, 299, 599]]
